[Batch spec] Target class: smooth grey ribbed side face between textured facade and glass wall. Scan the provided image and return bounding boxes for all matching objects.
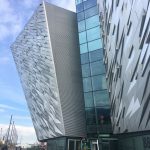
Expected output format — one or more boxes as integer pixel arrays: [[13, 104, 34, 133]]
[[46, 2, 86, 137]]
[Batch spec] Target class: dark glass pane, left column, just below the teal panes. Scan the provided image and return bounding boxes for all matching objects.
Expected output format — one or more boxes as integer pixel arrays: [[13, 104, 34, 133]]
[[85, 108, 96, 125]]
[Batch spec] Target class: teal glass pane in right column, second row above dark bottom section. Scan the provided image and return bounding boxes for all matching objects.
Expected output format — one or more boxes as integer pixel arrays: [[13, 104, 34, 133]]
[[92, 75, 107, 90]]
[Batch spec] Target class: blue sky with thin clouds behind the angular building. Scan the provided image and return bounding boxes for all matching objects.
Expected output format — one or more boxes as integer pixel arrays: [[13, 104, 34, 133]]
[[0, 0, 75, 142]]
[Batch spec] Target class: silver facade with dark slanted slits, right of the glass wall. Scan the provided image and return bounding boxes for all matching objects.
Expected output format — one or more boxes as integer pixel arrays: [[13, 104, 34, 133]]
[[101, 0, 150, 133]]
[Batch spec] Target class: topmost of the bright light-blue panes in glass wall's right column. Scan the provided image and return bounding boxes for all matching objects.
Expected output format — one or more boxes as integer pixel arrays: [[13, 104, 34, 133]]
[[86, 15, 99, 29]]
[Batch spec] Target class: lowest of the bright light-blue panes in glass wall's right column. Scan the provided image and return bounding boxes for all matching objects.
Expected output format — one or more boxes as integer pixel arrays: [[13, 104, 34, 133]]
[[88, 39, 102, 51]]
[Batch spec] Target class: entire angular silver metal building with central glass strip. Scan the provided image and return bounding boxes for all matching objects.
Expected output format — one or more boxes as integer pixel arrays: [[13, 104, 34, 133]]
[[11, 0, 150, 150]]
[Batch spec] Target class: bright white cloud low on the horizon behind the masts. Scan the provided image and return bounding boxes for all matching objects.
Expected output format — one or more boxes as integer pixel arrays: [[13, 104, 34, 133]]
[[0, 124, 37, 144]]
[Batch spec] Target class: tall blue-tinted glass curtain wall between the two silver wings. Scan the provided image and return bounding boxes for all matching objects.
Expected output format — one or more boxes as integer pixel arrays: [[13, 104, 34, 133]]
[[76, 0, 111, 137]]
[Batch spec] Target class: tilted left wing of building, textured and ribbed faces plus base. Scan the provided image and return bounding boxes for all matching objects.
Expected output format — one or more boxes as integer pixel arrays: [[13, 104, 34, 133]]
[[11, 2, 86, 150]]
